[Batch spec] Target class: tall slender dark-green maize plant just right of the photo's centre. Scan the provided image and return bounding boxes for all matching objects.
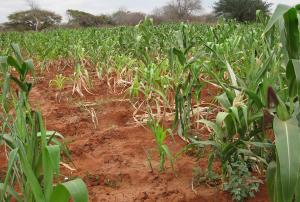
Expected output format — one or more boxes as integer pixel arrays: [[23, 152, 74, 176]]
[[169, 24, 202, 138]]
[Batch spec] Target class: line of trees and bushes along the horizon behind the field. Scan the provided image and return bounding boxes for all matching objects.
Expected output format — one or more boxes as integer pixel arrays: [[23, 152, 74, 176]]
[[0, 0, 270, 31]]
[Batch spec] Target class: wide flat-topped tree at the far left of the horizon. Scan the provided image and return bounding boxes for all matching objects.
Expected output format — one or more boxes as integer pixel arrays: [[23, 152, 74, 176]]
[[5, 9, 62, 31]]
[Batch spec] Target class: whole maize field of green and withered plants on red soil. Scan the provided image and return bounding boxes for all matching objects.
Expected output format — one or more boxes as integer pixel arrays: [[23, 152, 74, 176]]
[[0, 3, 300, 202]]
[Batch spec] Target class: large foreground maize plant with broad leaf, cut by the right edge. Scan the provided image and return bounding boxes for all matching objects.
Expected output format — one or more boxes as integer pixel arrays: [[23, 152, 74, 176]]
[[264, 4, 300, 202]]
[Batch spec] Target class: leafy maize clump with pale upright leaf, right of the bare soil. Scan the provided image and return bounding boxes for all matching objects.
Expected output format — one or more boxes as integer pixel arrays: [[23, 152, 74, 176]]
[[190, 19, 276, 186]]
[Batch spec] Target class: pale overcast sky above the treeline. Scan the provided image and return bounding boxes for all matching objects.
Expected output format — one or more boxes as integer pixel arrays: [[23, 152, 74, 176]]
[[0, 0, 300, 23]]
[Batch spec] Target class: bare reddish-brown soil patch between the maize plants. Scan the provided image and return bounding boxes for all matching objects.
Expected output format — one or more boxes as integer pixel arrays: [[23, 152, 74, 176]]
[[0, 65, 268, 202]]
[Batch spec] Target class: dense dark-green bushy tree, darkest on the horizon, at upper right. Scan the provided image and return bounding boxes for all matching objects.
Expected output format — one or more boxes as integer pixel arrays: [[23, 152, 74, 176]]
[[214, 0, 272, 22]]
